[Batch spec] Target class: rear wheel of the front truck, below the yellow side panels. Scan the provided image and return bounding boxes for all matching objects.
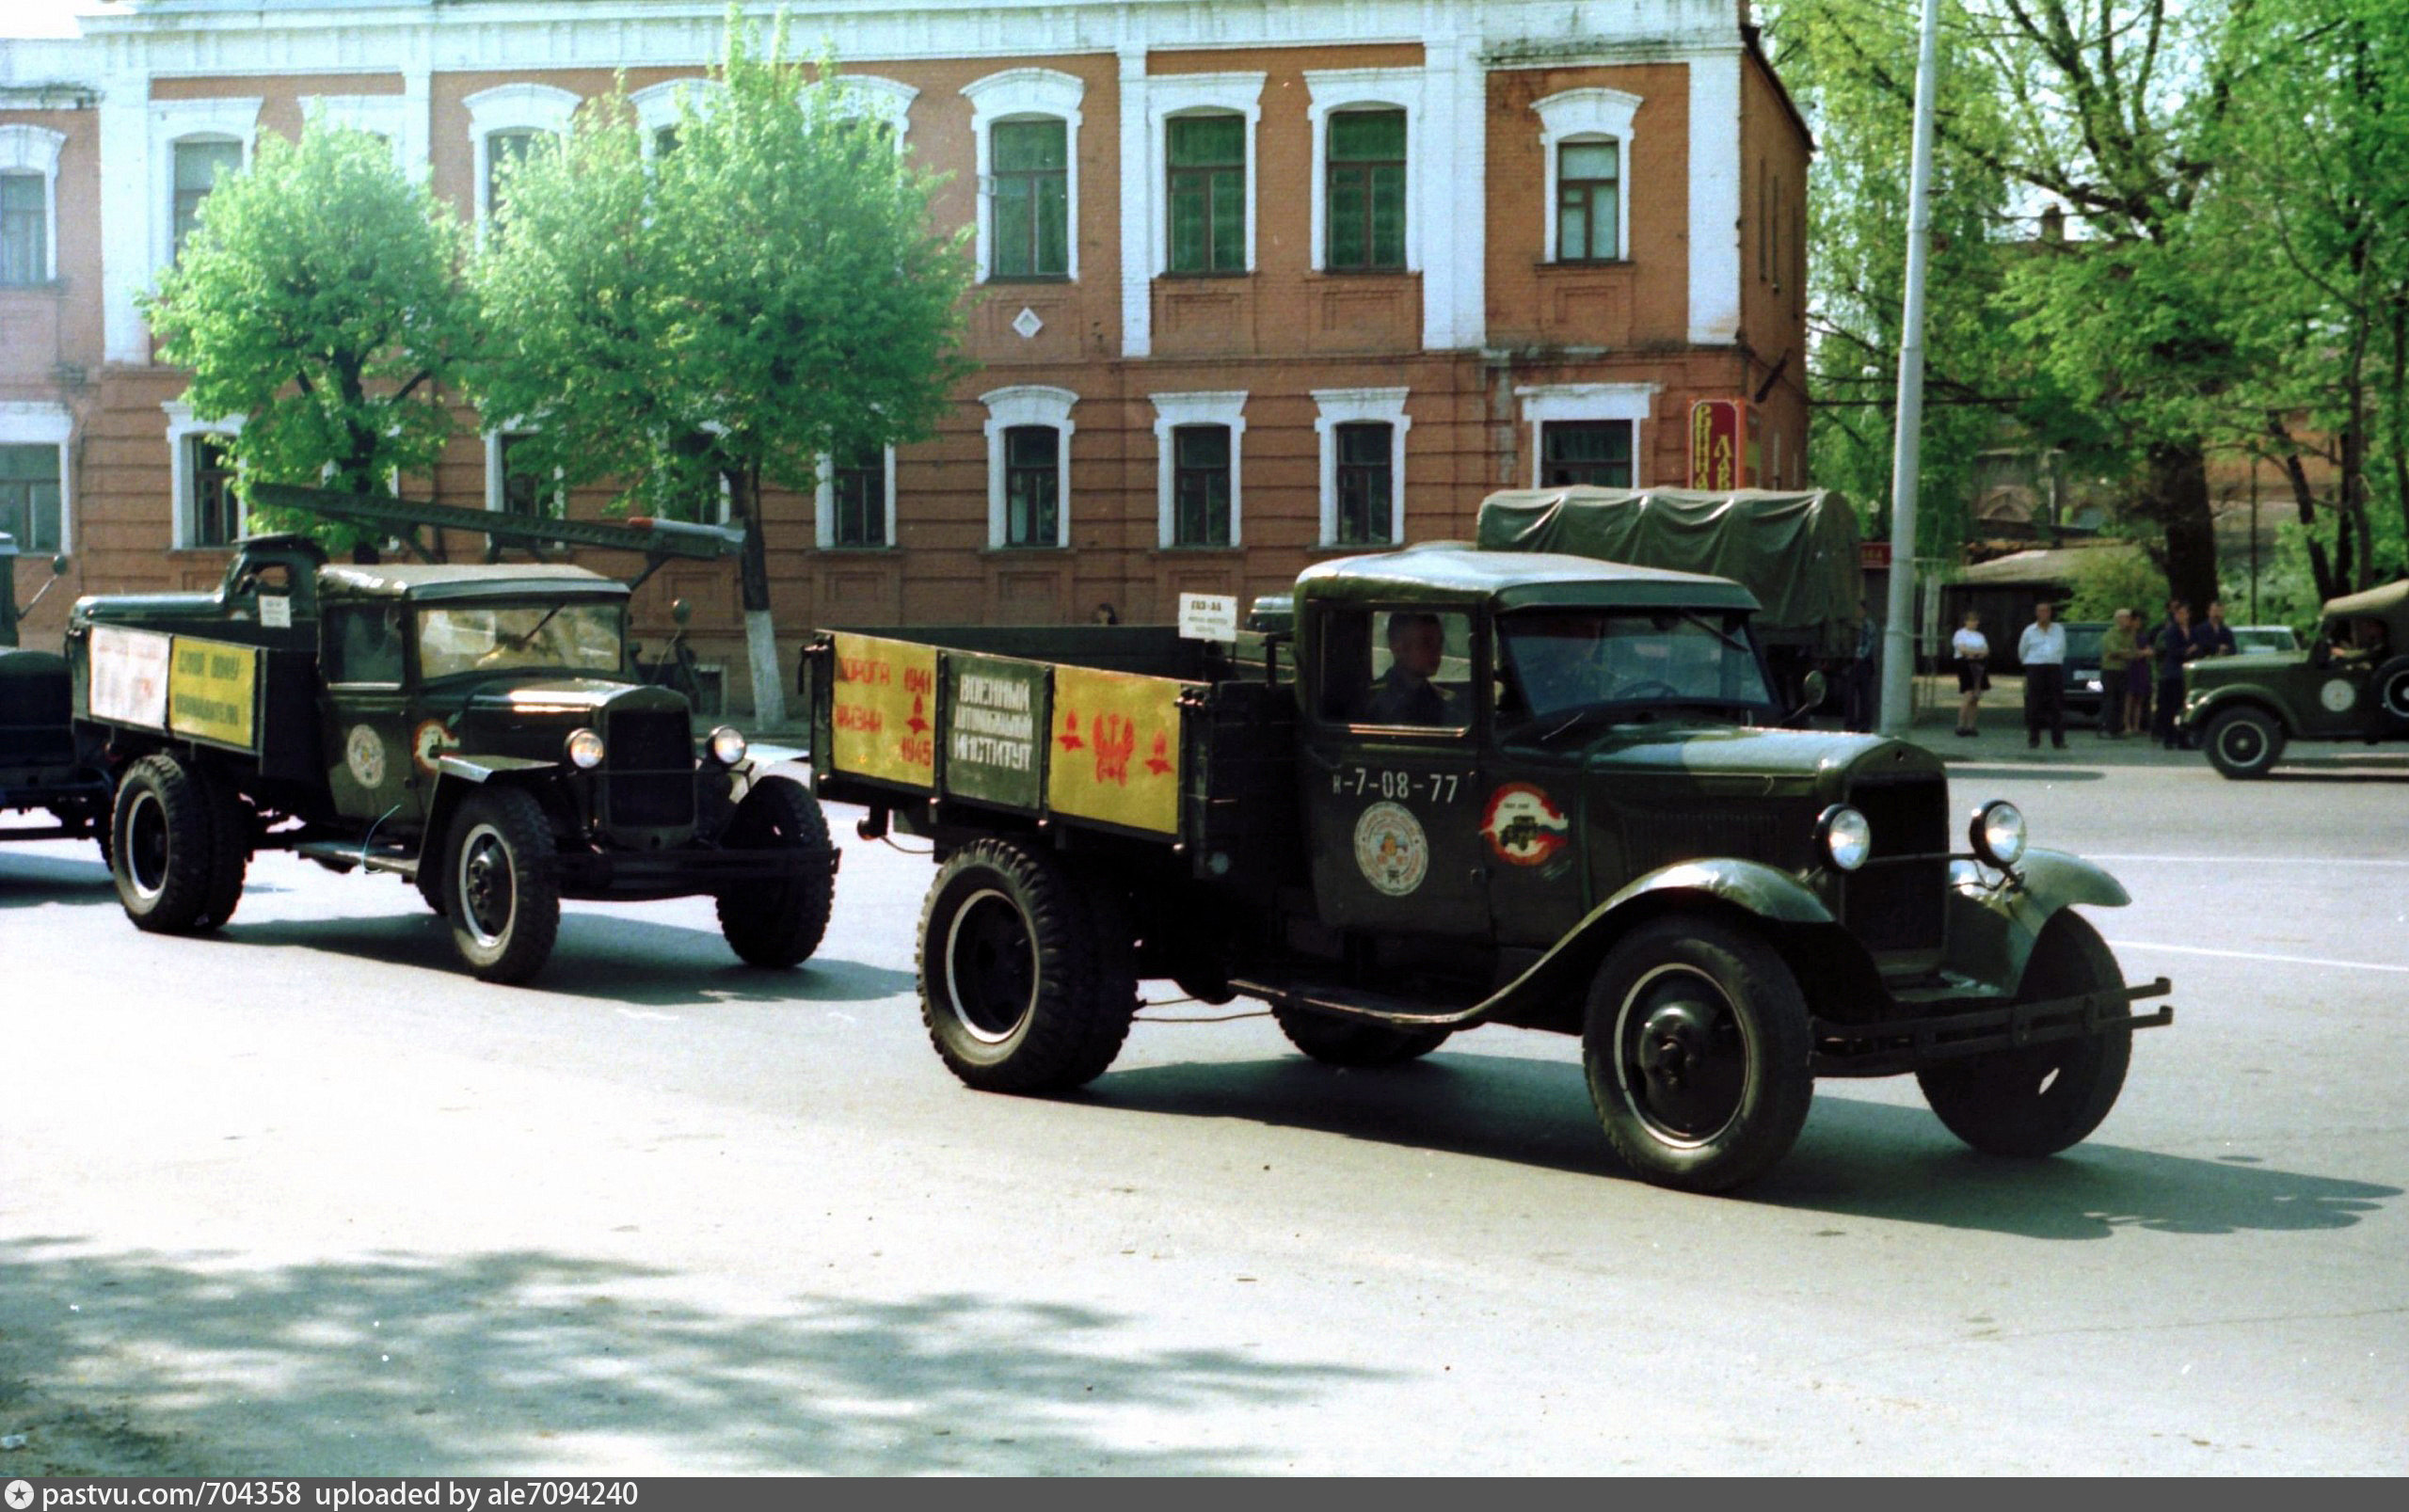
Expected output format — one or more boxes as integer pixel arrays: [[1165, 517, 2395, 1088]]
[[917, 840, 1137, 1093]]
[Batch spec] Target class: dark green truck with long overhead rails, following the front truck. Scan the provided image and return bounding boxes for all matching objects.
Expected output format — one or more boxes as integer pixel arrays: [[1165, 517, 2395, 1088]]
[[68, 486, 836, 982]]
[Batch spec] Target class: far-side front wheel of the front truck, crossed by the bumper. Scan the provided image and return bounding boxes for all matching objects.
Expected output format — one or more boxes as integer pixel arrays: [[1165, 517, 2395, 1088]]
[[1915, 913, 2132, 1160]]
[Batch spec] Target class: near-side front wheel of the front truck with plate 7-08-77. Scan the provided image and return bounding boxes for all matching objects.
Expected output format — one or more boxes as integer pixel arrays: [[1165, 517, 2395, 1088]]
[[1580, 915, 1814, 1192]]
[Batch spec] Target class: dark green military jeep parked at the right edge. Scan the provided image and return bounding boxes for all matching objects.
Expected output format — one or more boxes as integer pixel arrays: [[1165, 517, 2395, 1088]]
[[2182, 582, 2409, 780]]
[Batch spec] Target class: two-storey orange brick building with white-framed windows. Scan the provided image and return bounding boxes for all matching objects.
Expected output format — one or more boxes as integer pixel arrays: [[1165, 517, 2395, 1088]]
[[0, 0, 1811, 712]]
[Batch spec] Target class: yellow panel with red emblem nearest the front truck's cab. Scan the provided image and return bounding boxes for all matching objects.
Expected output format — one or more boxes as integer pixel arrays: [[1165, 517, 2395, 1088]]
[[1045, 667, 1180, 836]]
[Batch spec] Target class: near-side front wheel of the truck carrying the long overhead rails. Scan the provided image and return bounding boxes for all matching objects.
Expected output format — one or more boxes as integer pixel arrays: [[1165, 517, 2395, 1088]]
[[443, 788, 561, 982]]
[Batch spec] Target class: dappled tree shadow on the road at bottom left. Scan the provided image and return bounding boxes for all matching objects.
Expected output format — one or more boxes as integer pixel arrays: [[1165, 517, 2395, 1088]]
[[0, 1237, 1371, 1476]]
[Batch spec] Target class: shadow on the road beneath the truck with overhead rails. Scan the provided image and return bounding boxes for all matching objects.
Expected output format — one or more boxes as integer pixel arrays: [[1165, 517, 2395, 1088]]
[[216, 908, 913, 1007]]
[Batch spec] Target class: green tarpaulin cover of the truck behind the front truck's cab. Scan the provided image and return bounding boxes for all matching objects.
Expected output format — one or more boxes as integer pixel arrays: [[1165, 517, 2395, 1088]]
[[1476, 486, 1864, 658]]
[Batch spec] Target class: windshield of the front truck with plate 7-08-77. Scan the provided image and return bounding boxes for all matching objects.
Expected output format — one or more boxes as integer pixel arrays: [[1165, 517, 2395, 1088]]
[[1498, 609, 1773, 720]]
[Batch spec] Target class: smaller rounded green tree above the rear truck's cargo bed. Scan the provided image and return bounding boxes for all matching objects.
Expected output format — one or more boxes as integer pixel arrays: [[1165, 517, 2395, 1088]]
[[142, 118, 472, 549]]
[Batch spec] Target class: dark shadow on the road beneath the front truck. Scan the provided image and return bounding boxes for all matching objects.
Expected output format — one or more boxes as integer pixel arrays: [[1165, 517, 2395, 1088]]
[[1087, 1052, 2401, 1240]]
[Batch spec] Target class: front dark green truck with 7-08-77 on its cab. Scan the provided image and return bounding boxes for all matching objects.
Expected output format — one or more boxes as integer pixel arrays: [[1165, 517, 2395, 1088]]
[[807, 544, 2173, 1189]]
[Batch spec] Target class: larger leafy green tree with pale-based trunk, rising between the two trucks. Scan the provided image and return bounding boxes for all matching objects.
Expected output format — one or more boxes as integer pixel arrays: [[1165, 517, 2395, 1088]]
[[474, 12, 971, 724]]
